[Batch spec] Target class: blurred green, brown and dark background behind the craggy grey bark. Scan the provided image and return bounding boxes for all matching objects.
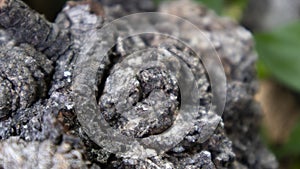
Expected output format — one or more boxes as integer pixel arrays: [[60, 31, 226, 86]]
[[24, 0, 300, 169]]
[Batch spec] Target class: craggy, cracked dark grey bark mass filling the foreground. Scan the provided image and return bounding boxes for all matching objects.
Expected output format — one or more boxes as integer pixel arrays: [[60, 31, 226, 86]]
[[0, 0, 277, 168]]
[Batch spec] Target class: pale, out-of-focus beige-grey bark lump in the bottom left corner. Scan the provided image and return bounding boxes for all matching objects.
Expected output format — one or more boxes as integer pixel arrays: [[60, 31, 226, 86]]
[[0, 137, 90, 169]]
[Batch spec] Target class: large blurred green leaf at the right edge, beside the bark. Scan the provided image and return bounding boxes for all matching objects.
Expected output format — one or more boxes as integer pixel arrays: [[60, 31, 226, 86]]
[[255, 22, 300, 91]]
